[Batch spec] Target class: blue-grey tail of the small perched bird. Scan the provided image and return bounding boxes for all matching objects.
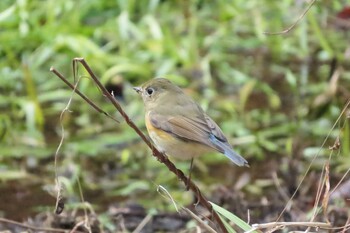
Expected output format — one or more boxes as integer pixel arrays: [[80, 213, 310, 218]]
[[209, 135, 249, 167]]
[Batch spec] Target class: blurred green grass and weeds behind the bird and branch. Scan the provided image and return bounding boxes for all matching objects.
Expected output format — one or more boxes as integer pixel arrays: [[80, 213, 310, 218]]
[[0, 0, 350, 231]]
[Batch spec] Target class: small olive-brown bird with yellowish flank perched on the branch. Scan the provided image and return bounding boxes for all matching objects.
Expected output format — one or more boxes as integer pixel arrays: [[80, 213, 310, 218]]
[[134, 78, 248, 167]]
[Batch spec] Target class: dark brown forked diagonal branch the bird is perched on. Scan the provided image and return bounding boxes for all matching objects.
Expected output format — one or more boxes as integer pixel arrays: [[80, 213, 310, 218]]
[[50, 58, 228, 233]]
